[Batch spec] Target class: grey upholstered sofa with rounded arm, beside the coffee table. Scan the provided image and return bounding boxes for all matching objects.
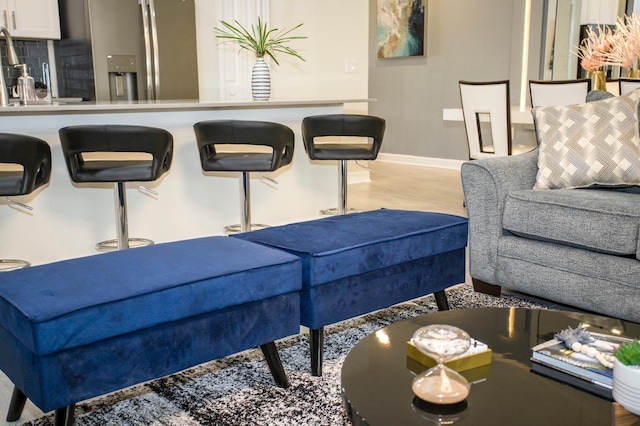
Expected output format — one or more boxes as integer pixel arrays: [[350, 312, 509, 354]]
[[462, 149, 640, 322]]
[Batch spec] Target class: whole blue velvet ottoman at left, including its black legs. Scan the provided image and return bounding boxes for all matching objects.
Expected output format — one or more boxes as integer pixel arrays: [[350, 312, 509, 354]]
[[0, 237, 301, 424]]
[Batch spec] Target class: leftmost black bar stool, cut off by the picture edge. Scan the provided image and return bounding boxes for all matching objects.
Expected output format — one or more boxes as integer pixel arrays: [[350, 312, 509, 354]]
[[0, 133, 51, 272]]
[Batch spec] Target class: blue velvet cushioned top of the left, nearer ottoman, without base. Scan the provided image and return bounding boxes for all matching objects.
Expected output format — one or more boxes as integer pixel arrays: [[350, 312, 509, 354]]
[[0, 237, 301, 355]]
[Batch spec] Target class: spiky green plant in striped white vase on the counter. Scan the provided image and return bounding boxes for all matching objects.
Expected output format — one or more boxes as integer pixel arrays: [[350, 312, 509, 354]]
[[214, 17, 306, 100]]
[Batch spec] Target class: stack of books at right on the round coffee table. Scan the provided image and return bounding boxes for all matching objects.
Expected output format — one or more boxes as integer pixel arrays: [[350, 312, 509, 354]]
[[531, 333, 631, 401]]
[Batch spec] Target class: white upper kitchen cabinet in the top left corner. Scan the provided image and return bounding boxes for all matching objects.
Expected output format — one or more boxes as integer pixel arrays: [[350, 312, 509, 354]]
[[0, 0, 60, 40]]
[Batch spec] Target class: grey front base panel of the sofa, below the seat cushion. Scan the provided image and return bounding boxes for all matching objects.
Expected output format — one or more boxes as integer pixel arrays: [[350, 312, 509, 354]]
[[496, 236, 640, 322]]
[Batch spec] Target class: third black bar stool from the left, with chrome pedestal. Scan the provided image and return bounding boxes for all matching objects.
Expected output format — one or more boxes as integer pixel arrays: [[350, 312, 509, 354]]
[[193, 120, 294, 234]]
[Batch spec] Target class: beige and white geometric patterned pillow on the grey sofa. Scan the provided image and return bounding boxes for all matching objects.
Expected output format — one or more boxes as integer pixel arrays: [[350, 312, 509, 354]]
[[532, 90, 640, 189]]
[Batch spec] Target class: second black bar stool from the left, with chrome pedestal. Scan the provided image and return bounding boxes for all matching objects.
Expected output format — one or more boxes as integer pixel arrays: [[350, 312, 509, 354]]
[[59, 125, 173, 250]]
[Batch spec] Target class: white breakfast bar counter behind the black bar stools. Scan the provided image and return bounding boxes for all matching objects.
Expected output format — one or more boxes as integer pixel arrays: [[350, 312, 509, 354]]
[[0, 99, 371, 264]]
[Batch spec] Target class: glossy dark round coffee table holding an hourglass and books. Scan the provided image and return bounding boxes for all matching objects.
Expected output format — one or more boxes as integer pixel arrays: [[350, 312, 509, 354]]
[[341, 308, 640, 426]]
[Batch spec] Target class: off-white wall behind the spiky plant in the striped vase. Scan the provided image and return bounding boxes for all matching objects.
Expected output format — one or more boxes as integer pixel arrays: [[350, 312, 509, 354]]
[[196, 0, 369, 113]]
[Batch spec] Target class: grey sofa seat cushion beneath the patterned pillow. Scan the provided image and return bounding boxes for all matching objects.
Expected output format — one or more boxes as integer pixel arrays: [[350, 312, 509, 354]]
[[503, 189, 640, 256]]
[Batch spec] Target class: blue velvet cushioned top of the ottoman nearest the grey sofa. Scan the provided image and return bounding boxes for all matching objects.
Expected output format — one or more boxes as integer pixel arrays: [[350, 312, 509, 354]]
[[234, 209, 467, 287]]
